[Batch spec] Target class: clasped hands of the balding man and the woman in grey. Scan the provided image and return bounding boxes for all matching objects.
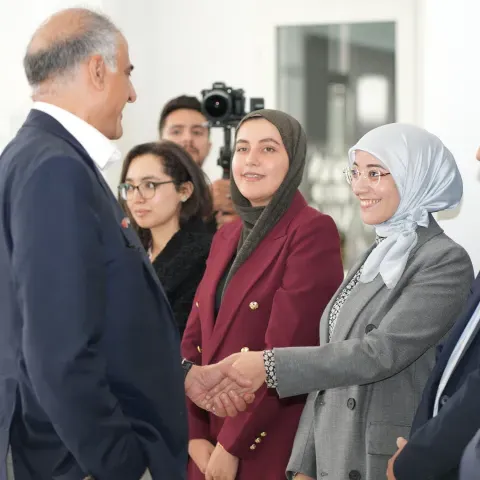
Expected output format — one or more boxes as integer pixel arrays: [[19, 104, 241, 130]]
[[185, 352, 266, 417]]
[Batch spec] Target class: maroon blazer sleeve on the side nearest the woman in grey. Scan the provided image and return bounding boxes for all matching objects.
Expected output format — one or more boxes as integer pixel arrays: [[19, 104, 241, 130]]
[[218, 215, 343, 458]]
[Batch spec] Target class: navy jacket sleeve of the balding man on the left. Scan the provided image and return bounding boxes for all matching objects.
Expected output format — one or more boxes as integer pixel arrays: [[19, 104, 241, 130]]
[[11, 157, 146, 480]]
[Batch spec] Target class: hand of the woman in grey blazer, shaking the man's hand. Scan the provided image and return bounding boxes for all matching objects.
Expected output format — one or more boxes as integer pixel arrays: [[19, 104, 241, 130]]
[[205, 352, 266, 413]]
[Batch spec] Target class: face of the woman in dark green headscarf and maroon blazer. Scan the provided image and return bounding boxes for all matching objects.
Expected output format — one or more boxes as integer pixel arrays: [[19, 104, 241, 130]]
[[232, 118, 290, 207]]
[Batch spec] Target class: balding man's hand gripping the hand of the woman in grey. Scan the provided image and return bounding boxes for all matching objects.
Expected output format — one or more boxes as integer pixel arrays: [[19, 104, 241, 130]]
[[185, 356, 255, 417]]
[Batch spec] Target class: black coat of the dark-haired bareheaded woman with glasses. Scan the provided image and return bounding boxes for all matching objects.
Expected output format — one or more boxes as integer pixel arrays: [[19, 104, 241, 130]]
[[153, 222, 213, 336]]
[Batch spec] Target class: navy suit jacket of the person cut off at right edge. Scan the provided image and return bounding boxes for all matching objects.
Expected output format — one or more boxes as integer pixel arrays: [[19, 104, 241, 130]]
[[394, 275, 480, 480]]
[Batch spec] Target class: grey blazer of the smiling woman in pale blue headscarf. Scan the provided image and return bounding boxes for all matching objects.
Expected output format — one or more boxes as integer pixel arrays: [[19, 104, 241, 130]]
[[274, 217, 473, 480]]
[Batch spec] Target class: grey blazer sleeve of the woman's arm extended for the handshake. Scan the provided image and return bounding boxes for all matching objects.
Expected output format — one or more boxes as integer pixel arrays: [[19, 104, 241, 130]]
[[274, 237, 473, 397]]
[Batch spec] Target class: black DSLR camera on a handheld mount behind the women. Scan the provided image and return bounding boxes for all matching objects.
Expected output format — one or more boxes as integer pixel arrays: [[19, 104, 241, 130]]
[[202, 82, 265, 178]]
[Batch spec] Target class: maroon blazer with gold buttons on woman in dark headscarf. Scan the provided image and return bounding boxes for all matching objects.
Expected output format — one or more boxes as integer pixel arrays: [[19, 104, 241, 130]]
[[182, 192, 343, 480]]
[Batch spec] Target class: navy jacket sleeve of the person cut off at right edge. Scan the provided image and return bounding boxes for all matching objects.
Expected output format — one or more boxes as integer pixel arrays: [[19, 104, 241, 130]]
[[394, 369, 480, 480]]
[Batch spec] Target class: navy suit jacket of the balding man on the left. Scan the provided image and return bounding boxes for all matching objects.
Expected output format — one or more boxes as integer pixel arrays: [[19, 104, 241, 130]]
[[0, 110, 188, 480]]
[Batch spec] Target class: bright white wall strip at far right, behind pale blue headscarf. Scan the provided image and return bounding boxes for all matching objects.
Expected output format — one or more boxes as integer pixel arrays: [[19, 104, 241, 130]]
[[421, 0, 480, 270]]
